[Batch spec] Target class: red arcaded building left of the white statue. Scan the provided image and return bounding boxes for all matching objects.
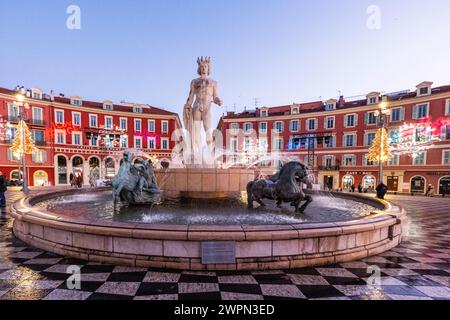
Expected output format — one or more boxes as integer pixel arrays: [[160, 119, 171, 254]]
[[0, 88, 181, 186]]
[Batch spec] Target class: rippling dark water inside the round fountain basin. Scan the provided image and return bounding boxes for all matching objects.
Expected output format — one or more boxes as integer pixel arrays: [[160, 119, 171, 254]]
[[37, 192, 374, 225]]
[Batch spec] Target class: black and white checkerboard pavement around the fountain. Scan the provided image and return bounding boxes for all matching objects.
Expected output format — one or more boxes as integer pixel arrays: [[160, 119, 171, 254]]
[[0, 191, 450, 300]]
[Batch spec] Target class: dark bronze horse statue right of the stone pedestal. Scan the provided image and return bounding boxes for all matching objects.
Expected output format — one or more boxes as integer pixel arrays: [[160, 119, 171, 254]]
[[247, 161, 312, 212]]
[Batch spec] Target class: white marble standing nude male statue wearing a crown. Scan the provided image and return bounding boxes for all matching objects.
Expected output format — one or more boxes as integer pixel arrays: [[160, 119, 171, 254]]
[[183, 57, 222, 164]]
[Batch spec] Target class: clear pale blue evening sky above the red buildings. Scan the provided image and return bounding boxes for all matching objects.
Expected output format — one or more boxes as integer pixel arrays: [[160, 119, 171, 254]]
[[0, 0, 450, 124]]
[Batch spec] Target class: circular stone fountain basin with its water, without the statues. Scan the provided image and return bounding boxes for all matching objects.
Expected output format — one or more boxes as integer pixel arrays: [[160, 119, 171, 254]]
[[12, 188, 405, 270]]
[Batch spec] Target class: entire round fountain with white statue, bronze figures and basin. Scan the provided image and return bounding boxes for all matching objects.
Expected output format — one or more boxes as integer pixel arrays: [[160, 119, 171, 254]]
[[11, 58, 405, 270]]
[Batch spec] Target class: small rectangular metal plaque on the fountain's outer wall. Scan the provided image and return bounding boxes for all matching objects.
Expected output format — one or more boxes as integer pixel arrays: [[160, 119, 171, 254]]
[[202, 241, 236, 264]]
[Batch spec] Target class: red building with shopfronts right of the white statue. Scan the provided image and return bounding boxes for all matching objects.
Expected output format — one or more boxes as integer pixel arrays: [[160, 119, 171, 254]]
[[218, 82, 450, 194]]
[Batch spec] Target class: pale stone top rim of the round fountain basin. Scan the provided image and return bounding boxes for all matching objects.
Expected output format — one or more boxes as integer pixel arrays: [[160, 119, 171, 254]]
[[12, 187, 405, 238]]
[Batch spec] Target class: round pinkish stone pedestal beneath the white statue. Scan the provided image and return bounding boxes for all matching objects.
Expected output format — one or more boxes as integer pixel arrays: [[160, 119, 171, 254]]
[[155, 167, 255, 199]]
